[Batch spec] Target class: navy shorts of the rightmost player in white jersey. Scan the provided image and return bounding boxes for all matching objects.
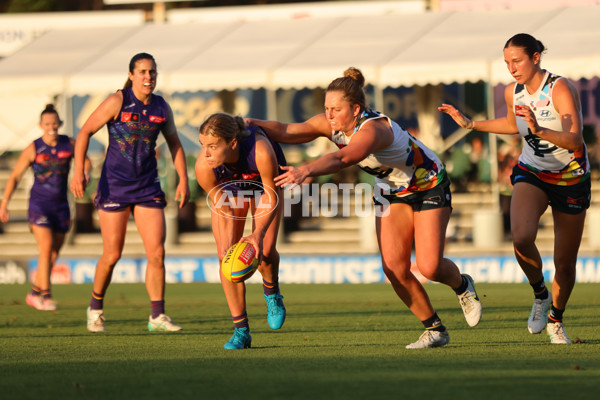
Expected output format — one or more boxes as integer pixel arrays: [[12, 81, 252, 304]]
[[510, 165, 591, 214]]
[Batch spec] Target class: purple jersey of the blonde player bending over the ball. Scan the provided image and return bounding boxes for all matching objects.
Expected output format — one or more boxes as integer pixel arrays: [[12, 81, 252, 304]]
[[213, 126, 286, 189]]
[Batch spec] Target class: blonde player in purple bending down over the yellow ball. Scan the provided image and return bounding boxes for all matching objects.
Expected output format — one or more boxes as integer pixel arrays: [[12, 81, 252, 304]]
[[196, 113, 286, 349]]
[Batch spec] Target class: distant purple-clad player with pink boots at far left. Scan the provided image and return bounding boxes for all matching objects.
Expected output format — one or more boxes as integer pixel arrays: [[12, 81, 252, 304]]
[[0, 104, 85, 310]]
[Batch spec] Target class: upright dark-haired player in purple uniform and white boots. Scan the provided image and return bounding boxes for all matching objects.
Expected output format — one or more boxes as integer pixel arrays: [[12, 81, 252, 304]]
[[71, 53, 189, 332]]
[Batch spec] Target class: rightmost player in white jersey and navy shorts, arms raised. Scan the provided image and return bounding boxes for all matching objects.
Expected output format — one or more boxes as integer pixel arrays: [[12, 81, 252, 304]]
[[439, 33, 590, 344]]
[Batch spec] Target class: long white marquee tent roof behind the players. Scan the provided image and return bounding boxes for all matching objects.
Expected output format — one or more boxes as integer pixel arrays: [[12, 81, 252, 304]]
[[0, 6, 600, 153]]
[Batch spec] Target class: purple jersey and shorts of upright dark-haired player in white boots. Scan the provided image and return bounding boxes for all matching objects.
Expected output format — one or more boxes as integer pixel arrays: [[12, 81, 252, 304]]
[[96, 88, 169, 204]]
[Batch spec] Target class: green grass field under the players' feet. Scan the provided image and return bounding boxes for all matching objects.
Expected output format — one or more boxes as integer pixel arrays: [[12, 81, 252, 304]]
[[0, 284, 600, 400]]
